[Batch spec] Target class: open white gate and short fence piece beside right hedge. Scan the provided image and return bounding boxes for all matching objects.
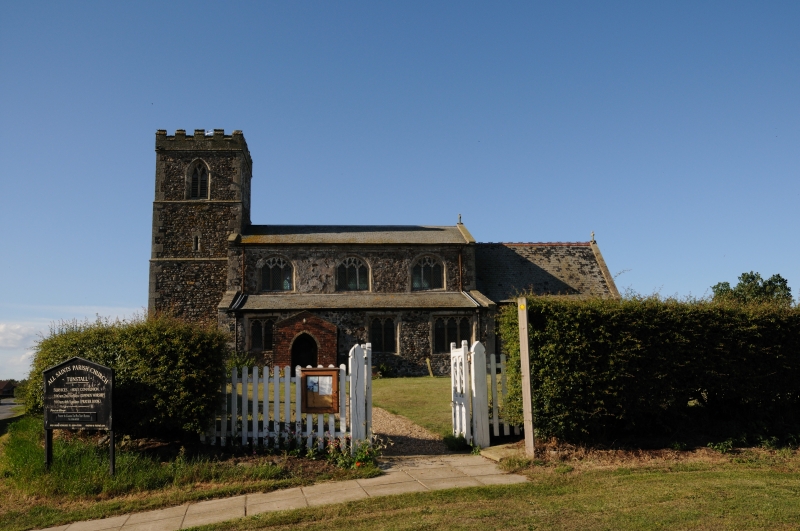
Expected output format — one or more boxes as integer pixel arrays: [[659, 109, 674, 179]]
[[450, 341, 520, 448]]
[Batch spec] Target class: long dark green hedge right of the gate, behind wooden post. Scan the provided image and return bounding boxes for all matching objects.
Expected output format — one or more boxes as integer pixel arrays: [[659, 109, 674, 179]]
[[499, 297, 800, 441]]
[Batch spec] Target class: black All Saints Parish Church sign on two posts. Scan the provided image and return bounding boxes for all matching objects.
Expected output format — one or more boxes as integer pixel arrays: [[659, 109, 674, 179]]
[[43, 357, 116, 476]]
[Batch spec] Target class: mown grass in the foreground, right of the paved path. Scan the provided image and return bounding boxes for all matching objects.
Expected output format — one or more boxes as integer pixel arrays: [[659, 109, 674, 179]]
[[192, 456, 800, 531]]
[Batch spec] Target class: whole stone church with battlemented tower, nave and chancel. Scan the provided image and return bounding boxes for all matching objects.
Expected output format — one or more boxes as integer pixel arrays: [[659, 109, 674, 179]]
[[148, 129, 619, 375]]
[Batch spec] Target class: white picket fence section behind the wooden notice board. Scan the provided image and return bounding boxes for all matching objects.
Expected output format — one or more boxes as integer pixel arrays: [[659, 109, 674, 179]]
[[200, 343, 372, 451]]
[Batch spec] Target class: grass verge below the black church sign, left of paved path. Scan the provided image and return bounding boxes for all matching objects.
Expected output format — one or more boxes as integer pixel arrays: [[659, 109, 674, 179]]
[[0, 417, 380, 531]]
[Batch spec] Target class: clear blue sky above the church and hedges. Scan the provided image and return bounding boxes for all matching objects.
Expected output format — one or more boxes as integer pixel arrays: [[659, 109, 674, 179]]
[[0, 1, 800, 378]]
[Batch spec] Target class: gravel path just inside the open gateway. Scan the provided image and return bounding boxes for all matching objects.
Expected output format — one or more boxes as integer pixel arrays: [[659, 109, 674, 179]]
[[372, 406, 453, 456]]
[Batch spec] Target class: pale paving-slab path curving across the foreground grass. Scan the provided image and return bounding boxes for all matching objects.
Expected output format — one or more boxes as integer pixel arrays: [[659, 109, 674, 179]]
[[39, 455, 526, 531]]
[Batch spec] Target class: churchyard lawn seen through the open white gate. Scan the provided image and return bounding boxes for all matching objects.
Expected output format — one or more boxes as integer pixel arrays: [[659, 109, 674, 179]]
[[372, 376, 453, 437]]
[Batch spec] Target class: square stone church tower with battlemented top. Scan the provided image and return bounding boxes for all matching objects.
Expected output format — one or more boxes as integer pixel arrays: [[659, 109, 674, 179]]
[[148, 129, 253, 322]]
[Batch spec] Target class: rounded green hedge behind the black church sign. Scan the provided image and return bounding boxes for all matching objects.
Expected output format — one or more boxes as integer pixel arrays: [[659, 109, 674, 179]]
[[25, 316, 228, 437]]
